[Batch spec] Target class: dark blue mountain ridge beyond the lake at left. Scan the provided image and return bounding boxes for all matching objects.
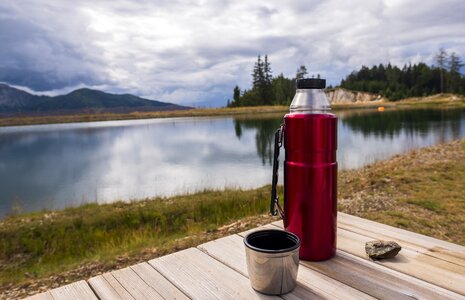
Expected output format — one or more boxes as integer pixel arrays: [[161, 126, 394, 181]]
[[0, 83, 190, 115]]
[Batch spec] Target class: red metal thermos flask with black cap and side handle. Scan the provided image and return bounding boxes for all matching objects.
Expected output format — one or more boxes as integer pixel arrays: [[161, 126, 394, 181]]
[[270, 78, 337, 261]]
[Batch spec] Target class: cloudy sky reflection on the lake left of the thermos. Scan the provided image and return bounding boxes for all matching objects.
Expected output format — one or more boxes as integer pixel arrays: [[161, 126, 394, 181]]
[[0, 118, 269, 214]]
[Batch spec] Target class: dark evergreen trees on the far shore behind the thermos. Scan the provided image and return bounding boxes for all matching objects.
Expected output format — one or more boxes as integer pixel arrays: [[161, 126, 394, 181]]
[[227, 49, 465, 107]]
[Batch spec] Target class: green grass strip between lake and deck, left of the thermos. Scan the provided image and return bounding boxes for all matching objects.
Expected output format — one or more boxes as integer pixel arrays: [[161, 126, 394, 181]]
[[0, 187, 280, 286]]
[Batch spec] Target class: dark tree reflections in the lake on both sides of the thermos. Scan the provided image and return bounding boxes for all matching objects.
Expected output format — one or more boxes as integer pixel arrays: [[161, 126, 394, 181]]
[[234, 108, 465, 166]]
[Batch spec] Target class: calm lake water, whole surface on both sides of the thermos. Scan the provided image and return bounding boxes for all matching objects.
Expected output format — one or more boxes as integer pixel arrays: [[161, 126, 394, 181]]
[[0, 109, 465, 217]]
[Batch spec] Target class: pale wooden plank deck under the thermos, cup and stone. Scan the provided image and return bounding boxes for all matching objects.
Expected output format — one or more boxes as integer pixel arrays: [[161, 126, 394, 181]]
[[24, 213, 465, 299]]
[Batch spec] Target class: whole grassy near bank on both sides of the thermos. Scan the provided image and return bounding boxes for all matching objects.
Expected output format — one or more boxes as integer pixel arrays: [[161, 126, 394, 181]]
[[0, 140, 465, 298]]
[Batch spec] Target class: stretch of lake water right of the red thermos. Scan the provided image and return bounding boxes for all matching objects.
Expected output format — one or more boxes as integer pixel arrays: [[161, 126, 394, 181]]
[[338, 108, 465, 169]]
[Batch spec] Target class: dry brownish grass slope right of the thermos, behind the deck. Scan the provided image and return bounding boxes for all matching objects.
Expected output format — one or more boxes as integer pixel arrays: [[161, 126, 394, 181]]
[[339, 140, 465, 245]]
